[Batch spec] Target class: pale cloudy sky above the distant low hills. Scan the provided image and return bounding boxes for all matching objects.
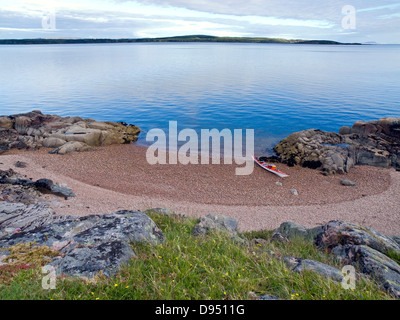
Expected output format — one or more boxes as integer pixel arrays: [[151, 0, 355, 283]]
[[0, 0, 400, 44]]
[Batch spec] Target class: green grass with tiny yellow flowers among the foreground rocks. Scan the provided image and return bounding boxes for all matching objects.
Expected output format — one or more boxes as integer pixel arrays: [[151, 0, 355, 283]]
[[0, 214, 392, 300]]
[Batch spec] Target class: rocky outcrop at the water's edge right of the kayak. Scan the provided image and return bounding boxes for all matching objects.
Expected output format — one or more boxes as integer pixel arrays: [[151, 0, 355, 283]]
[[274, 118, 400, 174]]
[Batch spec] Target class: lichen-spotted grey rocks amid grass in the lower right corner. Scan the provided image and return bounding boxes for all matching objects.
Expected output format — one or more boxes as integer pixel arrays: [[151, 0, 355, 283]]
[[275, 220, 400, 298]]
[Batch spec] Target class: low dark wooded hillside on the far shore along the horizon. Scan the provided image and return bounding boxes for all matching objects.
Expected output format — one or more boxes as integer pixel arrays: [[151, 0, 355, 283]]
[[0, 35, 361, 45]]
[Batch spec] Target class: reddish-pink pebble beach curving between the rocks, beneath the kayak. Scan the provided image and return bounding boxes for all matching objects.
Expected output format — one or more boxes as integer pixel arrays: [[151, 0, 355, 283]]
[[0, 145, 400, 235]]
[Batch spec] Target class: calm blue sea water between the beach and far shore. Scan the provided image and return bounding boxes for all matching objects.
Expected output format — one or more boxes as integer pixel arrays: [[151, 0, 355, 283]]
[[0, 43, 400, 152]]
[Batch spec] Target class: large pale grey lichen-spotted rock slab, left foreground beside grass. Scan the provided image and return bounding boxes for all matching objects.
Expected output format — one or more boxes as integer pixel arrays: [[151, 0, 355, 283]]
[[0, 209, 165, 278]]
